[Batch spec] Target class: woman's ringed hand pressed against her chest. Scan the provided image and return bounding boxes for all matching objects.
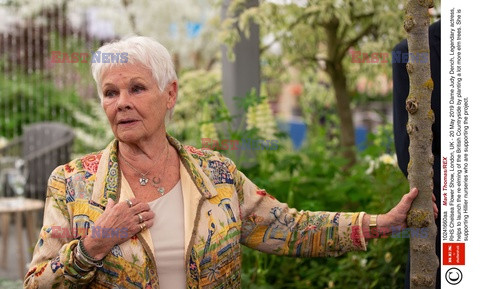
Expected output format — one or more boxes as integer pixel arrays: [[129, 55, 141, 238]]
[[83, 199, 155, 260]]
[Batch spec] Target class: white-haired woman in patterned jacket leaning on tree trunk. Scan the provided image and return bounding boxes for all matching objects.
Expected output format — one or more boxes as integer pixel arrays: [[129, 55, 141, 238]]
[[25, 37, 437, 289]]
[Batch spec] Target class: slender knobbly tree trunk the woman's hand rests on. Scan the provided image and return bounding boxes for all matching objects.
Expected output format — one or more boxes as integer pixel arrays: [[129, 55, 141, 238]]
[[404, 0, 439, 288]]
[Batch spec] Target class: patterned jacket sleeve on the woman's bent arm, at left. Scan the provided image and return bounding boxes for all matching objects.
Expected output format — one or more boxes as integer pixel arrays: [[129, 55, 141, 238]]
[[24, 167, 96, 288]]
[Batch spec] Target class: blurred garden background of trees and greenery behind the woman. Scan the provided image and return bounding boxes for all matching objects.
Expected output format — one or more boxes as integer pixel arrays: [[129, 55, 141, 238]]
[[0, 0, 440, 289]]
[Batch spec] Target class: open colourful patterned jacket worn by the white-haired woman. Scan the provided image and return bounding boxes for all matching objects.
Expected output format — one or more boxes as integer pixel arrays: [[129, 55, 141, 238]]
[[24, 136, 366, 289]]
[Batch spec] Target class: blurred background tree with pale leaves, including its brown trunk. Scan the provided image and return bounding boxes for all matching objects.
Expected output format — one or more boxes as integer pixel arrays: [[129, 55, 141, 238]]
[[220, 0, 405, 164]]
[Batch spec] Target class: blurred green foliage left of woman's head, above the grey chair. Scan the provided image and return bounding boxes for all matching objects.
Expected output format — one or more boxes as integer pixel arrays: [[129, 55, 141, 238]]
[[0, 68, 113, 154]]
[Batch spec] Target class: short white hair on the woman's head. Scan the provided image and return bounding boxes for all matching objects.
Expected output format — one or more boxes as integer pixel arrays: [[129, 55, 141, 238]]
[[91, 36, 178, 118]]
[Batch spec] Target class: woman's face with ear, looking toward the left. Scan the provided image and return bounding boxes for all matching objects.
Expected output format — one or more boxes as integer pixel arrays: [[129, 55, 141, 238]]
[[101, 64, 177, 144]]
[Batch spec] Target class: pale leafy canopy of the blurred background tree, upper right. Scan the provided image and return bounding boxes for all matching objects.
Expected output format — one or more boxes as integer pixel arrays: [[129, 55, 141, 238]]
[[220, 0, 406, 91]]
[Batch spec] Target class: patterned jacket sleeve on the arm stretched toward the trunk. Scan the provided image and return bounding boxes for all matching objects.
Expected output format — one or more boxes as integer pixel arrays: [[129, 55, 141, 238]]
[[217, 153, 367, 257]]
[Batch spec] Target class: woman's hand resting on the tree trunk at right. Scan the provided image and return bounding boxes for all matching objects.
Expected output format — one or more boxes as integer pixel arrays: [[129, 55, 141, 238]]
[[377, 188, 438, 232]]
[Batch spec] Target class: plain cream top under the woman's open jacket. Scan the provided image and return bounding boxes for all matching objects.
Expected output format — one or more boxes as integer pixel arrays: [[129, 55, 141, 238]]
[[148, 181, 187, 289]]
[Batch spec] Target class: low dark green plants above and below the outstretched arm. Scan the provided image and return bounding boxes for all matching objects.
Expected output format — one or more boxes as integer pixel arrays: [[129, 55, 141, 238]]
[[236, 122, 408, 289]]
